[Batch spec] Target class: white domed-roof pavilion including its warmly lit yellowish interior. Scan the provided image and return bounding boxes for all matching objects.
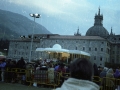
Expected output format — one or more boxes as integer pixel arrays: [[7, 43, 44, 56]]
[[36, 44, 90, 63]]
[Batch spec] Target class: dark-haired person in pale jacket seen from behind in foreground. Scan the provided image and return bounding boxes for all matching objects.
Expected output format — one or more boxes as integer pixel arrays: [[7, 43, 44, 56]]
[[55, 58, 100, 90]]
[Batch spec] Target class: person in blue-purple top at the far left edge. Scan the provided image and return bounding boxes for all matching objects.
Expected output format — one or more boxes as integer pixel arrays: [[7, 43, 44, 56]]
[[0, 58, 6, 82]]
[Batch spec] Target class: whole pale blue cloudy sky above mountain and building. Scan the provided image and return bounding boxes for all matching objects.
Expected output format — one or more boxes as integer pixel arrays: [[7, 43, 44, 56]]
[[0, 0, 120, 35]]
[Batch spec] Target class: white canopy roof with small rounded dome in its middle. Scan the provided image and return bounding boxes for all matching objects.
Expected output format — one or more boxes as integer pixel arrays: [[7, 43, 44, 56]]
[[36, 44, 90, 56]]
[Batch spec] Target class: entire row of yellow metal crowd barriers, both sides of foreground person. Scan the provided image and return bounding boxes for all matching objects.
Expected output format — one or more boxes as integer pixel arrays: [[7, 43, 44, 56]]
[[1, 68, 120, 90]]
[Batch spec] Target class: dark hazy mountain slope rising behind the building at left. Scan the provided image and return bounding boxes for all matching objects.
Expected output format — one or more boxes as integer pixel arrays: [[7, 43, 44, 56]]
[[0, 10, 51, 38]]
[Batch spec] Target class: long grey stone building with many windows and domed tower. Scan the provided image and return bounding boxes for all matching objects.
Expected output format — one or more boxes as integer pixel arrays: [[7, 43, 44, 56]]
[[8, 9, 120, 66]]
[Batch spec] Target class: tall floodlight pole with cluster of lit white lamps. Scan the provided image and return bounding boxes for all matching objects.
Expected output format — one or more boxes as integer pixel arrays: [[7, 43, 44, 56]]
[[29, 13, 40, 62]]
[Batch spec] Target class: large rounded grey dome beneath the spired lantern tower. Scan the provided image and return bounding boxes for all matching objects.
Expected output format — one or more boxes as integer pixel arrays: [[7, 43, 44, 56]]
[[86, 25, 109, 36]]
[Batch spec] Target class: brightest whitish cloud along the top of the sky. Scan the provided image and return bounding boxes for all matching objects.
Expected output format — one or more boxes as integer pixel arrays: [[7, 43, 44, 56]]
[[6, 0, 92, 21]]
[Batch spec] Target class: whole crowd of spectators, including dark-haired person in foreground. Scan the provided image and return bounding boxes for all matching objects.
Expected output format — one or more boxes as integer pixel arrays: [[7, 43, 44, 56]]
[[0, 57, 120, 90]]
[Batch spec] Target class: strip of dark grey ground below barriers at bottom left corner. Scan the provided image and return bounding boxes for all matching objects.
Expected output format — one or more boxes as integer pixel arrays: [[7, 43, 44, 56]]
[[0, 82, 53, 90]]
